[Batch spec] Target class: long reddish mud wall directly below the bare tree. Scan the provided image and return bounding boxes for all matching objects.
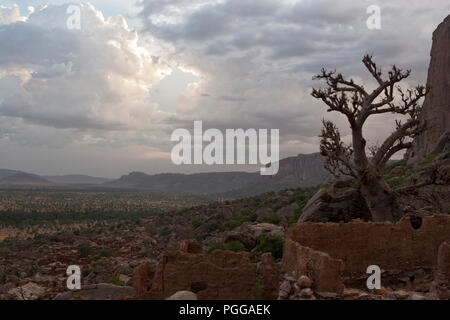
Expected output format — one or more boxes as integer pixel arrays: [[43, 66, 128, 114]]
[[283, 214, 450, 276]]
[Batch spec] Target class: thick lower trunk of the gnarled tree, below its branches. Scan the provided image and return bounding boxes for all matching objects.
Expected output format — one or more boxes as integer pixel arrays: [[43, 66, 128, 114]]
[[361, 167, 403, 222]]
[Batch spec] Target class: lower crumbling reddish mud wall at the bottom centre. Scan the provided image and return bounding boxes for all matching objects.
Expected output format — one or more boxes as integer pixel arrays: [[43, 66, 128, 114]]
[[134, 241, 279, 300]]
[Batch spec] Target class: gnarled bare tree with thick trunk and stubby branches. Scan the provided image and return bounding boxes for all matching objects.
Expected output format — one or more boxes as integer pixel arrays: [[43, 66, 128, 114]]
[[312, 55, 429, 221]]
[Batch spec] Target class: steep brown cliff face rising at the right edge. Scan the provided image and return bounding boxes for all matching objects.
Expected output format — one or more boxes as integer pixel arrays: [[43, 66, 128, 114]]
[[407, 15, 450, 162]]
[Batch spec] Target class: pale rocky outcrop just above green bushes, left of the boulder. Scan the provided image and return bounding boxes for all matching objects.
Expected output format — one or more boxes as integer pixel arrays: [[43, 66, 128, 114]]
[[224, 222, 284, 249]]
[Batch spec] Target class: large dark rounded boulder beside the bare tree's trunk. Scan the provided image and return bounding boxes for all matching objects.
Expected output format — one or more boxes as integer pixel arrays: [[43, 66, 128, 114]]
[[299, 180, 371, 222]]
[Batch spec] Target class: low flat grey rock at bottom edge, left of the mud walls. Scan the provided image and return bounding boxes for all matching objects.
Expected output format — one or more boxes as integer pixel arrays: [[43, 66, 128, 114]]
[[54, 283, 133, 300]]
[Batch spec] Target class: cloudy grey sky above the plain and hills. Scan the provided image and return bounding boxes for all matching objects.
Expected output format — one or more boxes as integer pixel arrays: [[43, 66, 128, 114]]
[[0, 0, 450, 178]]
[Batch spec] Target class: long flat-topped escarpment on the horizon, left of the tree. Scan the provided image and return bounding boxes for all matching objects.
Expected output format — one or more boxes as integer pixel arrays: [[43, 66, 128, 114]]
[[102, 153, 329, 195]]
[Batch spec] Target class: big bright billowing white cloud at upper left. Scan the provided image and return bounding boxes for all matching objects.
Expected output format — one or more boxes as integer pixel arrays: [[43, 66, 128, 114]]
[[0, 4, 172, 130]]
